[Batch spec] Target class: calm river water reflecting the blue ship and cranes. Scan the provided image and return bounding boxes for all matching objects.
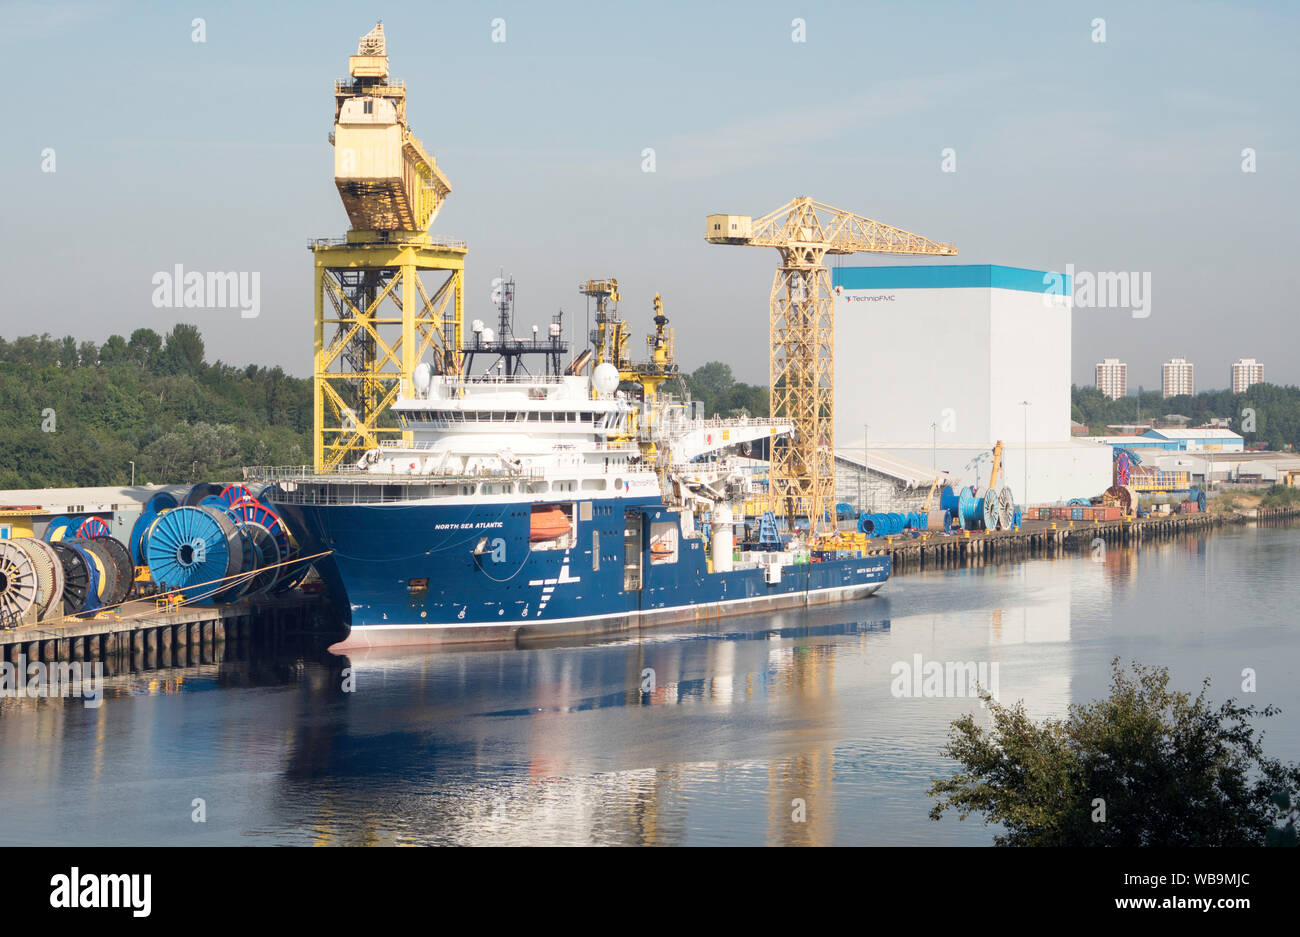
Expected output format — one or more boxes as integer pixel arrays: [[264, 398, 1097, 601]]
[[0, 528, 1300, 845]]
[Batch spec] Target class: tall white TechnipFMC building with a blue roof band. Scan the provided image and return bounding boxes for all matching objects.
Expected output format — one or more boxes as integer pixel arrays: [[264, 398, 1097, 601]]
[[832, 264, 1112, 504]]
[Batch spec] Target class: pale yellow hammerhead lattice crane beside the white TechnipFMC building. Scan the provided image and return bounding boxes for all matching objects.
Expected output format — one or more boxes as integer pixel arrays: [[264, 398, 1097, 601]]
[[705, 196, 957, 533]]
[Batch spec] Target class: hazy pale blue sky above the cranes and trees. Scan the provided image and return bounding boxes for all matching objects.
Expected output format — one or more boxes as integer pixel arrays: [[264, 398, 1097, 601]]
[[0, 0, 1300, 390]]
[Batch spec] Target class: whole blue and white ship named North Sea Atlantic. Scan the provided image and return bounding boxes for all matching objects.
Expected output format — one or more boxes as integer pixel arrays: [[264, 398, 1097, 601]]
[[248, 287, 889, 650]]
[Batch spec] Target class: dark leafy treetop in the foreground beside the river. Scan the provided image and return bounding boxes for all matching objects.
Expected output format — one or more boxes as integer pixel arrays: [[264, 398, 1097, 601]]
[[930, 658, 1300, 846]]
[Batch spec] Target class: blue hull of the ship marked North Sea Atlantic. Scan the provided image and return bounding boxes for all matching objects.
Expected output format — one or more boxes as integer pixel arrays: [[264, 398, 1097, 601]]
[[276, 498, 889, 650]]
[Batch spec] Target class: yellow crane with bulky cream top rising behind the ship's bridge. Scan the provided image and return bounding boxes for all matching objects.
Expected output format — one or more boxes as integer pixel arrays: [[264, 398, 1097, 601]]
[[311, 25, 468, 470]]
